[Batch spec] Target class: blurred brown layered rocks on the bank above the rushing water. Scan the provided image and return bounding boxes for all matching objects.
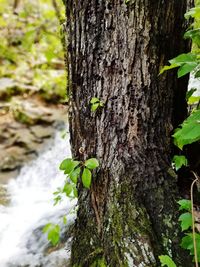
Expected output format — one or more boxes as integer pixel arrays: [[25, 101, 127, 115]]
[[0, 96, 67, 184]]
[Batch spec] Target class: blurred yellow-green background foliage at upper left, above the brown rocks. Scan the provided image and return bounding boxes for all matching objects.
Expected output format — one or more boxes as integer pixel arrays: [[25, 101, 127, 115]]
[[0, 0, 66, 101]]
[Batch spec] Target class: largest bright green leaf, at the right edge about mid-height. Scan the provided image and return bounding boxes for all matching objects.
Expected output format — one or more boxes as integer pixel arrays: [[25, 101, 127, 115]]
[[173, 110, 200, 149]]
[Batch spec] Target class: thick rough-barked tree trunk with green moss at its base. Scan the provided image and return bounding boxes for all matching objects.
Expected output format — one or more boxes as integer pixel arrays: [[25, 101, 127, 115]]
[[66, 0, 190, 267]]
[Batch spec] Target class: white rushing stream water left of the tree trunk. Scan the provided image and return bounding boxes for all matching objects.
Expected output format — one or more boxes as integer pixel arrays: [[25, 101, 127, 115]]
[[0, 133, 75, 267]]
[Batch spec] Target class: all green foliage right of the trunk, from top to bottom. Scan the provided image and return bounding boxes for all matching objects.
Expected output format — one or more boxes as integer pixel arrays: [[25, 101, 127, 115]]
[[159, 3, 200, 267]]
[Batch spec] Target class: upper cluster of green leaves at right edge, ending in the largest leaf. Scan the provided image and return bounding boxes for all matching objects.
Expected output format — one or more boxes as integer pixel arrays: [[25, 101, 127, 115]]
[[160, 5, 200, 153]]
